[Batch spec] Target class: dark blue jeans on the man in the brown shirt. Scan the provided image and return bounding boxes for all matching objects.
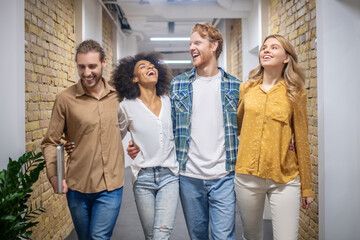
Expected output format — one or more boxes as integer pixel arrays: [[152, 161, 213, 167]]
[[66, 187, 123, 240]]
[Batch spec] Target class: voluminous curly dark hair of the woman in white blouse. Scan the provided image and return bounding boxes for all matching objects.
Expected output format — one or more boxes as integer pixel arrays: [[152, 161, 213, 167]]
[[111, 52, 173, 99]]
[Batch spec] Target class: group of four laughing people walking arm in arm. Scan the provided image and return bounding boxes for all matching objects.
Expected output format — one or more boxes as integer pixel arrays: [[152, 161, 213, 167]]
[[42, 23, 313, 240]]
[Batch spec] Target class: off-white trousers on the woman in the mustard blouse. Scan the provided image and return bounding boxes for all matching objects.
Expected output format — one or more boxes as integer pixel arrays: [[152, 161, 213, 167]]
[[234, 173, 300, 240]]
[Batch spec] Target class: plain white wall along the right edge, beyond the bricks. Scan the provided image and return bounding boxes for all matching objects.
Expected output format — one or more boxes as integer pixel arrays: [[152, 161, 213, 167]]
[[316, 0, 360, 240]]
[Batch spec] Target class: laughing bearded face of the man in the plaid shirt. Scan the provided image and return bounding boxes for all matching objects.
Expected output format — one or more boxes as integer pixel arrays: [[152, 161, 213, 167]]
[[190, 32, 218, 68]]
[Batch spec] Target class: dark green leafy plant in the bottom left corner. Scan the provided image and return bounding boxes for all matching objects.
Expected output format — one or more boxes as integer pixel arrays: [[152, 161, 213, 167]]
[[0, 152, 45, 239]]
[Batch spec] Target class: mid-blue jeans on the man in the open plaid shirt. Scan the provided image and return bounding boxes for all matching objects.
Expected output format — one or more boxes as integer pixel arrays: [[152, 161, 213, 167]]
[[180, 172, 236, 240]]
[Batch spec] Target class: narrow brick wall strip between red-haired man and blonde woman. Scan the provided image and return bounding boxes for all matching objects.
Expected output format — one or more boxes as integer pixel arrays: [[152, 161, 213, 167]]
[[229, 19, 243, 80]]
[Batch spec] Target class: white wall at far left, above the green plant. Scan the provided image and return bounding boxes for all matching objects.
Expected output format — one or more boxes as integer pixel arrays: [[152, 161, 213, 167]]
[[0, 0, 25, 170]]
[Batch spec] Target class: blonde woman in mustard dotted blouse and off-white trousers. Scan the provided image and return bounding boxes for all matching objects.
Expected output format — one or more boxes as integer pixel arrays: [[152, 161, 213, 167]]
[[235, 35, 313, 240]]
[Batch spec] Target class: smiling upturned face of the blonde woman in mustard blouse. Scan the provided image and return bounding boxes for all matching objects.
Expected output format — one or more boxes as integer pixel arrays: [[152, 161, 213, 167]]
[[259, 38, 289, 69]]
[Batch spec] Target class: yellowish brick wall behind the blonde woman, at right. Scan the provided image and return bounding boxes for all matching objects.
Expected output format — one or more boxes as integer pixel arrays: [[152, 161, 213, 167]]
[[270, 0, 319, 240]]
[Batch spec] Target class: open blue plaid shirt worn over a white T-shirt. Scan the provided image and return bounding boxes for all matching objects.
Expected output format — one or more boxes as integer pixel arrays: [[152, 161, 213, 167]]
[[170, 68, 241, 171]]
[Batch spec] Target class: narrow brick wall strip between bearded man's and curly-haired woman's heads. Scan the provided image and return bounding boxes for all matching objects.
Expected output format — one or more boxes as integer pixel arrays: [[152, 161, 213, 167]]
[[102, 9, 116, 80]]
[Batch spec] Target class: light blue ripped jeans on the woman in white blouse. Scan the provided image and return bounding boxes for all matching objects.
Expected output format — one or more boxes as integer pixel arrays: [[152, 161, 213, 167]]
[[134, 167, 179, 240]]
